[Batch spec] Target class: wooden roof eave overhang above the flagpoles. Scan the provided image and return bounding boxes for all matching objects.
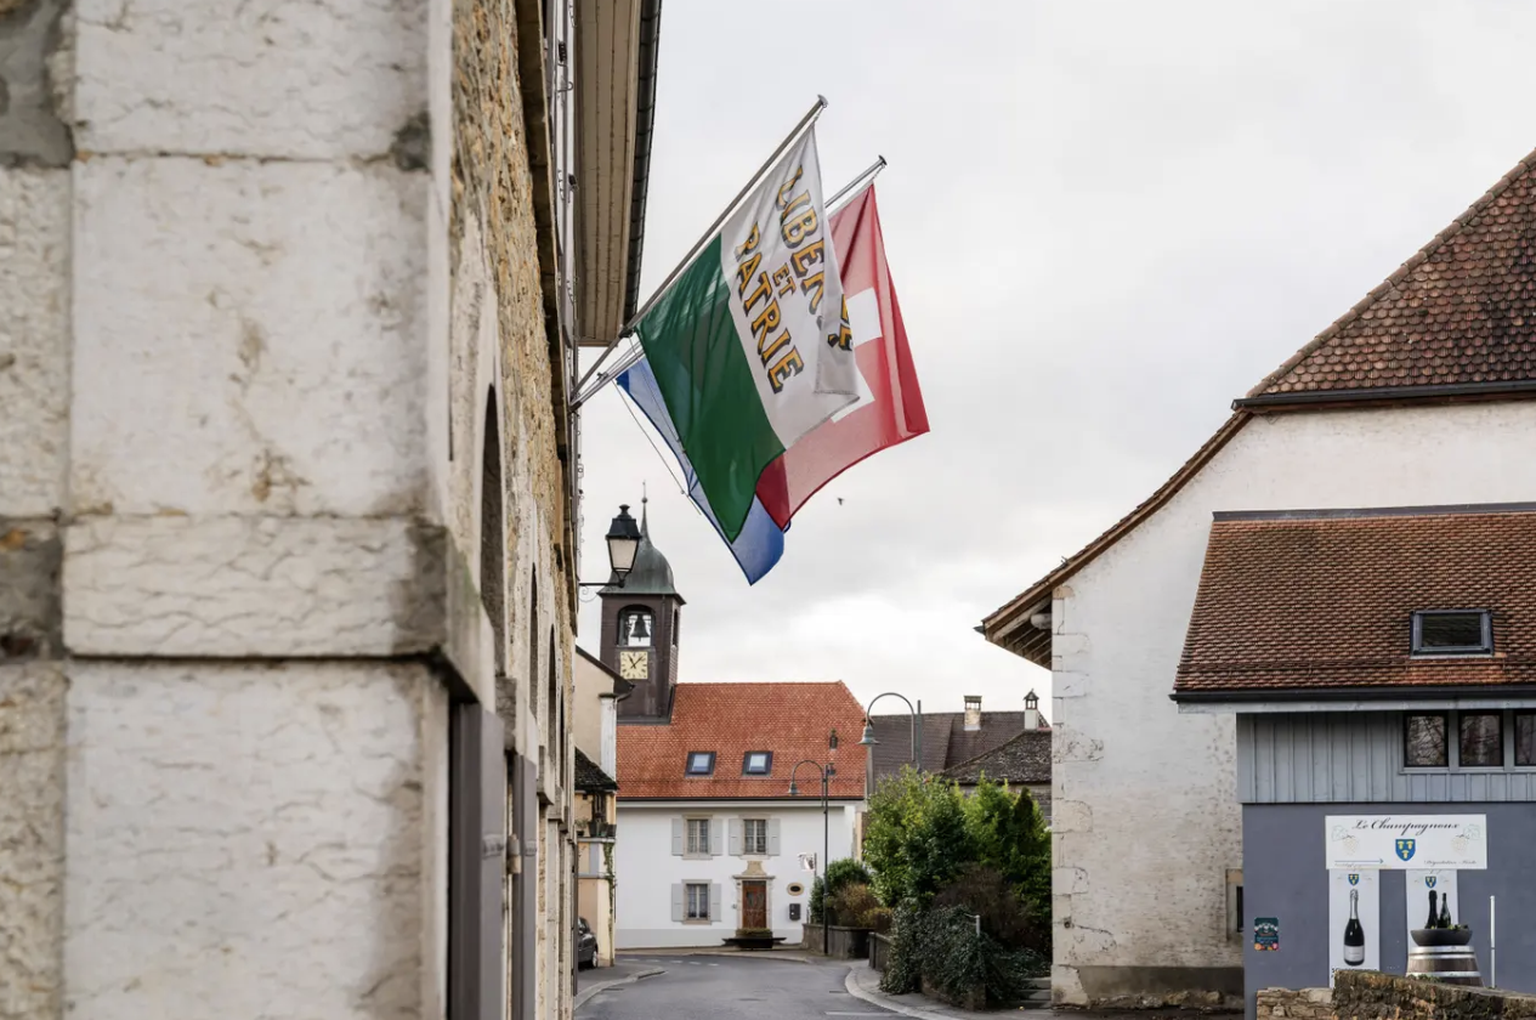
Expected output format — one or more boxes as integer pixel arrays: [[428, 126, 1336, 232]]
[[574, 0, 662, 347]]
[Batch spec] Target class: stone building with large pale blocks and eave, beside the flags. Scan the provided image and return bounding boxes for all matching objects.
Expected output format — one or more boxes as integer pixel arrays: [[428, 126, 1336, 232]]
[[0, 0, 659, 1020]]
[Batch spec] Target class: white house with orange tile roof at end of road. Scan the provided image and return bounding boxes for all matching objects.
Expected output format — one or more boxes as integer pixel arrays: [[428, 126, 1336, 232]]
[[614, 682, 865, 949]]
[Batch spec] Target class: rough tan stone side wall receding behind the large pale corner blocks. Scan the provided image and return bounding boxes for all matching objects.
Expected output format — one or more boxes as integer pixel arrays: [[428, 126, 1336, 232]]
[[448, 0, 591, 1020]]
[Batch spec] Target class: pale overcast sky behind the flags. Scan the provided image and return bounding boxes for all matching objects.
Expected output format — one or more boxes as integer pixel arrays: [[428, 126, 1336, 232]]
[[578, 0, 1536, 711]]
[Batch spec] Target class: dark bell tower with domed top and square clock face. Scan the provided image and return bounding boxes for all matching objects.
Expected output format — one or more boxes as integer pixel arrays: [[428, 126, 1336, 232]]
[[598, 498, 684, 719]]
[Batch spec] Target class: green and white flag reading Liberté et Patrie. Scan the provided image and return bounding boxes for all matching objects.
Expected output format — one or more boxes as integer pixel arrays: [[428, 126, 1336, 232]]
[[636, 128, 859, 541]]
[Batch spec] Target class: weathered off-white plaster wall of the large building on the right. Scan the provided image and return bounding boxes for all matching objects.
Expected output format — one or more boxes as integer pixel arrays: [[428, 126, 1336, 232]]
[[1052, 402, 1536, 1003]]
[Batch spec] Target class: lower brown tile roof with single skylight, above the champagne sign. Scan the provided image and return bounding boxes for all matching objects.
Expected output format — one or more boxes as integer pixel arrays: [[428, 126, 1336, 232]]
[[1174, 507, 1536, 700]]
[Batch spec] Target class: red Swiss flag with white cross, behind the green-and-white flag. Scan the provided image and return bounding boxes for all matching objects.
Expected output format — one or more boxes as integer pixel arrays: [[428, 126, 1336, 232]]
[[757, 184, 928, 528]]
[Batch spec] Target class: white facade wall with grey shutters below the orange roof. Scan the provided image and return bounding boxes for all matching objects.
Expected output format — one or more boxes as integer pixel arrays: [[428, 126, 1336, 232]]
[[614, 791, 857, 949]]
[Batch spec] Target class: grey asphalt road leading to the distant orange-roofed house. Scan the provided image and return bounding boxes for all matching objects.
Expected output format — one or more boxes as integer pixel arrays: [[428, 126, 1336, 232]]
[[581, 955, 900, 1020]]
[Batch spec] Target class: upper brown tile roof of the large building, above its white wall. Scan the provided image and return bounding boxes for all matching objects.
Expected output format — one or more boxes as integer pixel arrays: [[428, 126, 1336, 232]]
[[1249, 145, 1536, 398]]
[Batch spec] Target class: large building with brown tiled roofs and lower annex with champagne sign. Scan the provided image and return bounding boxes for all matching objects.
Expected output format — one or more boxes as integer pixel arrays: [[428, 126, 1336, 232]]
[[982, 143, 1536, 1015]]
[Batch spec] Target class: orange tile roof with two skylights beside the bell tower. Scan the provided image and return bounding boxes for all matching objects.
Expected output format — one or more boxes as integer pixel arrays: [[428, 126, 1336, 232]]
[[619, 682, 865, 800]]
